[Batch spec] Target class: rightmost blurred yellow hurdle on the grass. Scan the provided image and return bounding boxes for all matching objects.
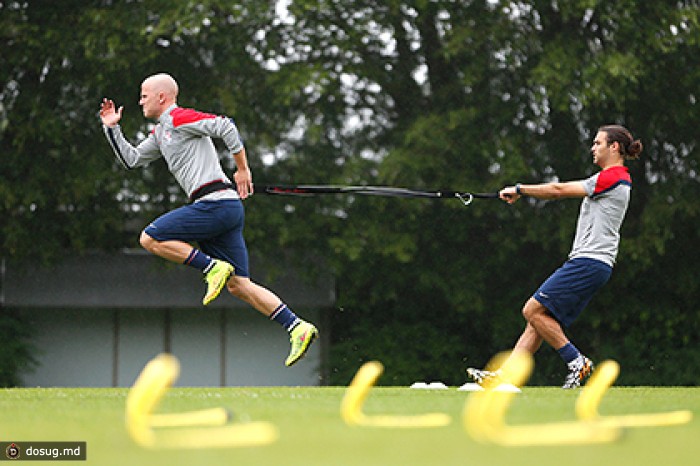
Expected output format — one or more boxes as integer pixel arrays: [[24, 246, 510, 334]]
[[576, 360, 693, 427]]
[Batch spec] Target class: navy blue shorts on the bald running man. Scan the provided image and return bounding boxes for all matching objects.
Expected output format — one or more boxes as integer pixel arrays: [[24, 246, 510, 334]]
[[144, 199, 249, 277]]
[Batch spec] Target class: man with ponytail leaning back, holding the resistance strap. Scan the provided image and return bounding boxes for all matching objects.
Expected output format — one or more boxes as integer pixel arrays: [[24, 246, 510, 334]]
[[467, 125, 642, 388]]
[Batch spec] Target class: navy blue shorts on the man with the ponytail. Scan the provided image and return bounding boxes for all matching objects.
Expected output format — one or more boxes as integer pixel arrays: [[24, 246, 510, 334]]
[[532, 257, 612, 327]]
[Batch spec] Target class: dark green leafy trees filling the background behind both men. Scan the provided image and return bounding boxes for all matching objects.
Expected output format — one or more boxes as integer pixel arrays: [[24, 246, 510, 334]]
[[0, 0, 700, 384]]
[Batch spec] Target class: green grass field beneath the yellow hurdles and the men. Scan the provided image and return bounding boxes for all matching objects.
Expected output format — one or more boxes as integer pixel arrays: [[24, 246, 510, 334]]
[[0, 387, 700, 466]]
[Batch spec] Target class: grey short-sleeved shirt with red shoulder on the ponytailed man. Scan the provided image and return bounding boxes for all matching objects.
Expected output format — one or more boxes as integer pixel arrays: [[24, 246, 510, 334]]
[[569, 166, 632, 267]]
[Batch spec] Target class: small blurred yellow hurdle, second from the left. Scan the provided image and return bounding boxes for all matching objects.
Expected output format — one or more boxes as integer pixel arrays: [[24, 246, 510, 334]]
[[340, 361, 452, 428]]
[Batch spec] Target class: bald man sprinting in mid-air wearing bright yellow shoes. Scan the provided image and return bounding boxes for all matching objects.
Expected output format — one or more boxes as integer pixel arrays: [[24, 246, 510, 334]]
[[100, 73, 318, 366]]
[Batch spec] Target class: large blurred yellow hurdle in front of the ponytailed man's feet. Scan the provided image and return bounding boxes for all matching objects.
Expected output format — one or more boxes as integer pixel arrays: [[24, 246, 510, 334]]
[[463, 353, 621, 446]]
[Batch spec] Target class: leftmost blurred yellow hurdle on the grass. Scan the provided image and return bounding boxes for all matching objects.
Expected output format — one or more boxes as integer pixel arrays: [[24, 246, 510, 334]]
[[126, 354, 279, 449]]
